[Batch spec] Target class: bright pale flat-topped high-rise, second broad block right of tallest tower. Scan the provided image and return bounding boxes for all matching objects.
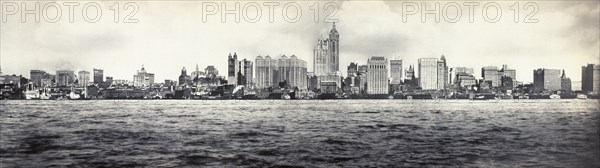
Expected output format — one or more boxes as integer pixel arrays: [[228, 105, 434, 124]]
[[418, 58, 439, 90]]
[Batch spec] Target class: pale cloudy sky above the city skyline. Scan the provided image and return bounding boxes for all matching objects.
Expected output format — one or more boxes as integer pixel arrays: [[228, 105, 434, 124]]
[[0, 0, 600, 82]]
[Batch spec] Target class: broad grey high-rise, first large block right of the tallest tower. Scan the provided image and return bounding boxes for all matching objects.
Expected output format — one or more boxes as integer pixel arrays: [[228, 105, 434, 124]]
[[367, 56, 389, 94]]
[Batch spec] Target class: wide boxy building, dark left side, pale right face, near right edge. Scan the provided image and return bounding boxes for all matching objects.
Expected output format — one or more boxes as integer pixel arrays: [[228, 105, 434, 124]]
[[533, 68, 561, 93]]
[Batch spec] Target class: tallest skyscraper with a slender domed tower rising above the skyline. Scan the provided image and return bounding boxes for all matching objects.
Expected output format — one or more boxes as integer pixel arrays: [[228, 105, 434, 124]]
[[313, 23, 340, 76]]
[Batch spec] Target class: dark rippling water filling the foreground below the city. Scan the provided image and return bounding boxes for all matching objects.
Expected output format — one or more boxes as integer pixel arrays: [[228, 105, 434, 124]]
[[0, 100, 600, 167]]
